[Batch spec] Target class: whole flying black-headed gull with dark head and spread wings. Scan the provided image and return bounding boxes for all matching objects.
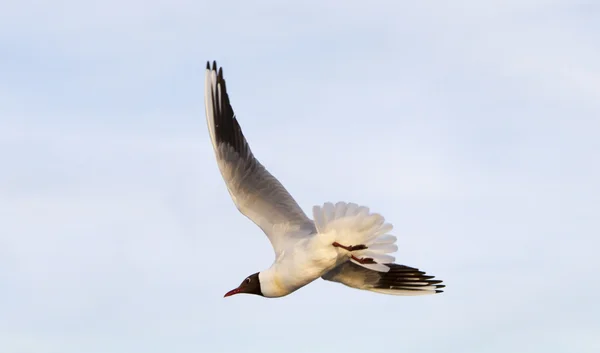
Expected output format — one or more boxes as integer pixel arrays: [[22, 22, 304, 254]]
[[204, 61, 445, 298]]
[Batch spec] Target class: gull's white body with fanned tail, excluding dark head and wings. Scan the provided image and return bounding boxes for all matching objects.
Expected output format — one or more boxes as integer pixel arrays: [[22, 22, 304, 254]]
[[259, 202, 397, 297]]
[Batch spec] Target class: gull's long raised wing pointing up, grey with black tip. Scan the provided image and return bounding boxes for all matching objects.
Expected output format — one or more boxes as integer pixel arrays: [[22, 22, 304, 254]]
[[204, 62, 315, 254]]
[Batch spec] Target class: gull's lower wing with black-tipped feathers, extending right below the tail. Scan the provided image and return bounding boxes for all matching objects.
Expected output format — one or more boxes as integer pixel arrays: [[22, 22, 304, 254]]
[[322, 261, 445, 295]]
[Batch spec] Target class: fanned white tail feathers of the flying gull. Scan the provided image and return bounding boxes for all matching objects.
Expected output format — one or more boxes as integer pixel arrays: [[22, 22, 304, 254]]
[[313, 202, 398, 272]]
